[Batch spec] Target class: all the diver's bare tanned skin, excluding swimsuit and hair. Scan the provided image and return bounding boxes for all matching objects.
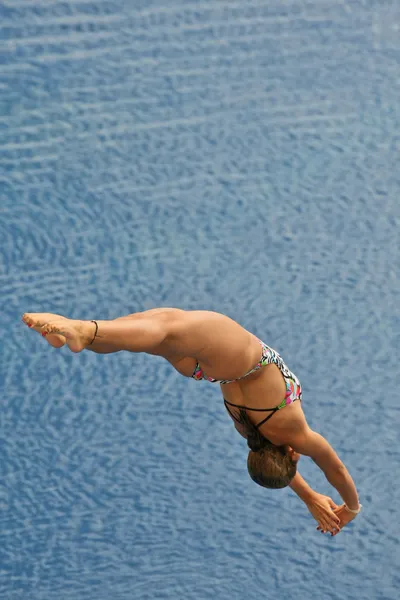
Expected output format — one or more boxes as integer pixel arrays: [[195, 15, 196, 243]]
[[22, 308, 360, 535]]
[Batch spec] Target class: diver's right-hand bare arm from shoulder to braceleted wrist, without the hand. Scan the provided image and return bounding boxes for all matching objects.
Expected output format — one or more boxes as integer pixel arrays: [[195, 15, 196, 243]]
[[290, 428, 360, 511]]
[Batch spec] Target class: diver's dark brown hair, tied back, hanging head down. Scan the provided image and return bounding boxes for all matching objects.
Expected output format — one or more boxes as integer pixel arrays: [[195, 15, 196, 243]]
[[240, 409, 297, 489]]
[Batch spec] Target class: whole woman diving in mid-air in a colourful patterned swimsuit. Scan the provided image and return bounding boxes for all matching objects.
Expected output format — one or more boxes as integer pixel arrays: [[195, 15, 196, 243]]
[[22, 308, 361, 535]]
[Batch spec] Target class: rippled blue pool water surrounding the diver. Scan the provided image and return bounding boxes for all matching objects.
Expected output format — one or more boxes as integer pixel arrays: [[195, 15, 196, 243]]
[[0, 0, 400, 600]]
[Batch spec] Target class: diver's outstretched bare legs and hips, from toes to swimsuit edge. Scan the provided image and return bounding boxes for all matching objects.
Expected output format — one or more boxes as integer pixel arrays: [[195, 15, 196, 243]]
[[23, 309, 260, 379]]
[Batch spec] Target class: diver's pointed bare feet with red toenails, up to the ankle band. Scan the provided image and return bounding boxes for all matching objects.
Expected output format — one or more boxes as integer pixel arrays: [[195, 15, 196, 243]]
[[22, 313, 96, 352]]
